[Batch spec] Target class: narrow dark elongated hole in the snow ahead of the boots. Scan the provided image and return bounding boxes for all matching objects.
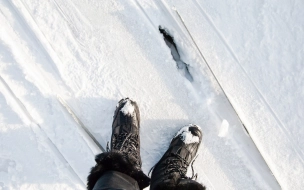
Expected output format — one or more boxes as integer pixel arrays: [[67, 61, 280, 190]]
[[159, 26, 193, 82]]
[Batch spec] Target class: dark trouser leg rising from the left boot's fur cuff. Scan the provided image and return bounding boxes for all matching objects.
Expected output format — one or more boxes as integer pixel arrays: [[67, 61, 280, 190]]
[[93, 171, 139, 190]]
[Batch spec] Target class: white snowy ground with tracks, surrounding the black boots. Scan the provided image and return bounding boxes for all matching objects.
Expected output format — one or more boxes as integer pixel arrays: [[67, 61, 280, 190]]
[[0, 0, 304, 189]]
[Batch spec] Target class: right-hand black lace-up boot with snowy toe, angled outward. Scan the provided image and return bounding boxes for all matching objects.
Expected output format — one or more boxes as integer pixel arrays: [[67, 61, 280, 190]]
[[150, 124, 205, 190]]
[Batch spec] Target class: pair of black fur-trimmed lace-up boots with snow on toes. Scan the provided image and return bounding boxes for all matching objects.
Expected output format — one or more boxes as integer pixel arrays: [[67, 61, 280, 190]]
[[87, 98, 205, 190]]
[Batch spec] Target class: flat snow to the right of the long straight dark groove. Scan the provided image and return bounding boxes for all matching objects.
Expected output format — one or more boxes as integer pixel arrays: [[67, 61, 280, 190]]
[[163, 1, 304, 189]]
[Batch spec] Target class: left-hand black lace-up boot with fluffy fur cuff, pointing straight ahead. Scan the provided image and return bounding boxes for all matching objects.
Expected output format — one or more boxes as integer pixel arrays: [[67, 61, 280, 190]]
[[87, 98, 150, 190]]
